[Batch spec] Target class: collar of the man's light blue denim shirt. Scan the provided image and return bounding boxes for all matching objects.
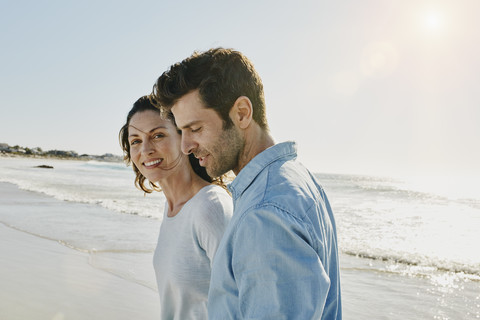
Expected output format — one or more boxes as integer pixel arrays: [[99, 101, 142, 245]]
[[228, 141, 297, 199]]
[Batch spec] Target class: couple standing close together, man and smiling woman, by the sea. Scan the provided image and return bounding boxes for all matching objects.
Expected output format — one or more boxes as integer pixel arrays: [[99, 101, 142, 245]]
[[120, 48, 342, 320]]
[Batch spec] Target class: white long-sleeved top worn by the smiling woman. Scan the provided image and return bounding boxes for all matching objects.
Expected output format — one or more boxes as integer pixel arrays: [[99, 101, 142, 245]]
[[153, 185, 233, 320]]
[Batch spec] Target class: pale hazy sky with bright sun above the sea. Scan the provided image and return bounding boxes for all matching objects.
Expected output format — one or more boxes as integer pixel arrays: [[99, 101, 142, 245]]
[[0, 0, 480, 176]]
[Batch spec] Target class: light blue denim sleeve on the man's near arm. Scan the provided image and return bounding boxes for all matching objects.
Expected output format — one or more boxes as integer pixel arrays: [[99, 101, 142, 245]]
[[233, 207, 330, 319]]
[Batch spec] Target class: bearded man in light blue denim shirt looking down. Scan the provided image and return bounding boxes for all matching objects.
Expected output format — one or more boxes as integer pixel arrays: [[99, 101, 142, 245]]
[[153, 48, 342, 320]]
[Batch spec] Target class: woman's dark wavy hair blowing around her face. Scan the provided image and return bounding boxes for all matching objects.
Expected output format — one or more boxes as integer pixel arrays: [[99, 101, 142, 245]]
[[118, 96, 225, 193]]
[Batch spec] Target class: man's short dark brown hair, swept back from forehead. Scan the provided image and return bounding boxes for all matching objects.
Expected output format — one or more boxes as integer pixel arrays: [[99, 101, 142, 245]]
[[152, 48, 268, 130]]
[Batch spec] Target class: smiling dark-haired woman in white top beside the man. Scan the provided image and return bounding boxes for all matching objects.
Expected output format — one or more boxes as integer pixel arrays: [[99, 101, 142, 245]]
[[119, 96, 233, 319]]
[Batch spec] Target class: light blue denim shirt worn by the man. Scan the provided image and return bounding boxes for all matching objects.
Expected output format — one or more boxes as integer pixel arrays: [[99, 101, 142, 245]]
[[208, 142, 342, 320]]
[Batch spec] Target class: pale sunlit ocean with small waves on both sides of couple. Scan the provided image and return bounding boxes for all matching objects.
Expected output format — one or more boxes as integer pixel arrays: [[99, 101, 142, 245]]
[[0, 157, 480, 319]]
